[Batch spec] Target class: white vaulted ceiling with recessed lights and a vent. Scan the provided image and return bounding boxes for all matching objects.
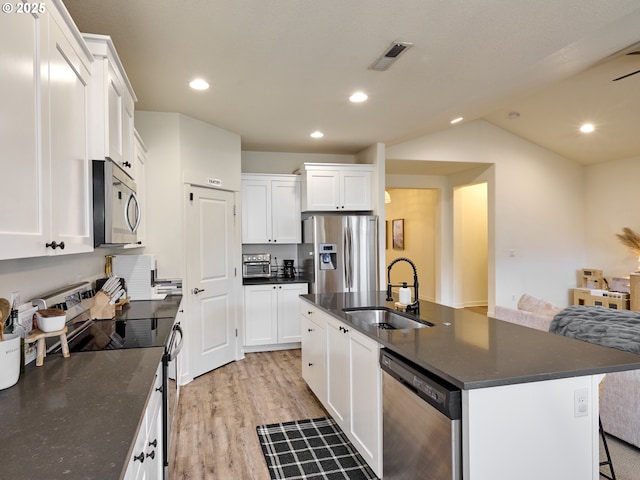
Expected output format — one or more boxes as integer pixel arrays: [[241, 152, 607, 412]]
[[63, 0, 640, 164]]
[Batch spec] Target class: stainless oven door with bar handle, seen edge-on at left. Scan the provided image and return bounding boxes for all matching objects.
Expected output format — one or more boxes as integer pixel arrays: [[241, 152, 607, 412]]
[[162, 323, 184, 480]]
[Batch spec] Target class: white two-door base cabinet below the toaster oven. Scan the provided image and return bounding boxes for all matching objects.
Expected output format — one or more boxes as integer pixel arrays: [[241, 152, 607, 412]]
[[244, 283, 308, 347]]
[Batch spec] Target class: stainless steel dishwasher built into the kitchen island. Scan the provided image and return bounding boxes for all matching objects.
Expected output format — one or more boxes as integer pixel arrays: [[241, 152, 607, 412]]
[[380, 349, 462, 480]]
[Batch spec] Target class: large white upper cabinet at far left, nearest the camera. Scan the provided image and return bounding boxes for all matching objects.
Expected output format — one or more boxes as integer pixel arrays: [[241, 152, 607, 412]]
[[0, 1, 93, 259]]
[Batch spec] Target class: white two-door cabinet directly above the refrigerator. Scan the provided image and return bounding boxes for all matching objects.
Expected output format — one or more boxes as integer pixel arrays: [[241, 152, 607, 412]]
[[300, 163, 373, 212]]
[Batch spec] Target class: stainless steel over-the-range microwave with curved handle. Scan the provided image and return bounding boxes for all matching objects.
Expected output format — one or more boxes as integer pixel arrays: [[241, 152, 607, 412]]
[[93, 159, 140, 247]]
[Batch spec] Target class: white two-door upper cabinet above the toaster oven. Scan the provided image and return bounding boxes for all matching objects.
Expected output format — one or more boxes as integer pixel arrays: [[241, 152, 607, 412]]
[[241, 174, 302, 244]]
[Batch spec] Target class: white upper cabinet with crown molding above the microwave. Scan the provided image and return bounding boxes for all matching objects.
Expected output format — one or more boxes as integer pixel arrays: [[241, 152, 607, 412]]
[[83, 34, 137, 180]]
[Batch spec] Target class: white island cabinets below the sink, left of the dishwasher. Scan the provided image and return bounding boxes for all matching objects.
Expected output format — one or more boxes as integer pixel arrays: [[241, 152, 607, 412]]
[[301, 301, 382, 477]]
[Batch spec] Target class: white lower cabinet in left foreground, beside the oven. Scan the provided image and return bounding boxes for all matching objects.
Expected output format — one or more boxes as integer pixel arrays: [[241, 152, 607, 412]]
[[124, 364, 164, 480]]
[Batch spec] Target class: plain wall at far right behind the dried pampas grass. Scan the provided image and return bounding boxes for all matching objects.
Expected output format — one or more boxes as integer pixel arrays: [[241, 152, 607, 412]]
[[584, 157, 640, 277]]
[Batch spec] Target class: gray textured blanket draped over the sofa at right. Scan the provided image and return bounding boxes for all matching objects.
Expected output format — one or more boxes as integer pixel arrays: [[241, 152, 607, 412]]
[[549, 305, 640, 354]]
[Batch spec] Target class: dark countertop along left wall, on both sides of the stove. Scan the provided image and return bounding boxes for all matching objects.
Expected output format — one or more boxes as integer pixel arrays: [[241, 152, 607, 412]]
[[0, 295, 182, 480]]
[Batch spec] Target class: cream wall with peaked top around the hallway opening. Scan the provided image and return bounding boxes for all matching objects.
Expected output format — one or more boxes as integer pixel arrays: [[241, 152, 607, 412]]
[[387, 120, 586, 309]]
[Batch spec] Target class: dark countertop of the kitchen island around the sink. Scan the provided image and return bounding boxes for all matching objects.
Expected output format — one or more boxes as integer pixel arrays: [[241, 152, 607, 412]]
[[301, 292, 640, 390]]
